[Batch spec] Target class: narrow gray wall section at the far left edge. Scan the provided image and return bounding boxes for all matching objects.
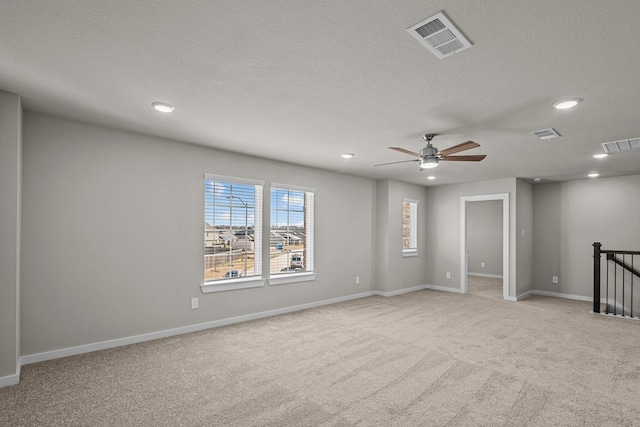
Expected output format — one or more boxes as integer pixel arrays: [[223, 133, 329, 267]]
[[0, 91, 22, 385]]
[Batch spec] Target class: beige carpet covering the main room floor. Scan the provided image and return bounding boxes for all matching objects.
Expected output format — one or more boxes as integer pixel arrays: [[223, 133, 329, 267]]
[[0, 283, 640, 426]]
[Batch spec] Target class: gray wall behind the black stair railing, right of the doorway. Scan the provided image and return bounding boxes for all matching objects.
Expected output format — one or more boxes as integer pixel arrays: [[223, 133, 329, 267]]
[[532, 175, 640, 297]]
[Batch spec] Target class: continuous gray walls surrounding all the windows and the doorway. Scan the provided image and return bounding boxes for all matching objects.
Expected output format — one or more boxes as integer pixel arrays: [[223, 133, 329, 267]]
[[7, 105, 640, 386]]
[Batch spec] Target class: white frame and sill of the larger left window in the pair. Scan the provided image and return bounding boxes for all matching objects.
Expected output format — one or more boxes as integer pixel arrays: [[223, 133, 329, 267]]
[[200, 173, 266, 293]]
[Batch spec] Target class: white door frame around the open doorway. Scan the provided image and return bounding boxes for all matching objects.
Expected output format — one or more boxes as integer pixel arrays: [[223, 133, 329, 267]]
[[460, 193, 509, 299]]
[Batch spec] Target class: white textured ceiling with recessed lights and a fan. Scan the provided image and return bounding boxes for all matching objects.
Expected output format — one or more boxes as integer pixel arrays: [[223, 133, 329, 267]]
[[0, 0, 640, 185]]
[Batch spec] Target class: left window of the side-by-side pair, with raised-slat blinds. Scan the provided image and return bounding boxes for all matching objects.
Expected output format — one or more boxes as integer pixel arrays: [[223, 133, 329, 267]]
[[203, 174, 264, 292]]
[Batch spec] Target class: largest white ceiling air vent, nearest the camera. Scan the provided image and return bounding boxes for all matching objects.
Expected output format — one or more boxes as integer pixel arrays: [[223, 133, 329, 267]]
[[407, 12, 471, 59]]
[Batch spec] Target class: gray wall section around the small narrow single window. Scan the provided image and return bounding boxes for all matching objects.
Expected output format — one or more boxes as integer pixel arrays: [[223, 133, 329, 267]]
[[375, 180, 434, 292]]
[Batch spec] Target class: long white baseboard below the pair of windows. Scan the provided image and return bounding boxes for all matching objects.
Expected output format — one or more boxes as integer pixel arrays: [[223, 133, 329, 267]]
[[21, 292, 374, 368]]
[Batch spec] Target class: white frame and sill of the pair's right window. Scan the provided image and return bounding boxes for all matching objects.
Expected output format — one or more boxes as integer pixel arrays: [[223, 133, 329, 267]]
[[269, 183, 316, 285]]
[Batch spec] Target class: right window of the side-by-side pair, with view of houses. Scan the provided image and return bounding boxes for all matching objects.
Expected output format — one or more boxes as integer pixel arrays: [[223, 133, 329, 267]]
[[269, 184, 315, 284]]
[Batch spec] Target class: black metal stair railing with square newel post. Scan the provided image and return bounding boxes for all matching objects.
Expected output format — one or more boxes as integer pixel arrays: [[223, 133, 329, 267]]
[[593, 242, 640, 319]]
